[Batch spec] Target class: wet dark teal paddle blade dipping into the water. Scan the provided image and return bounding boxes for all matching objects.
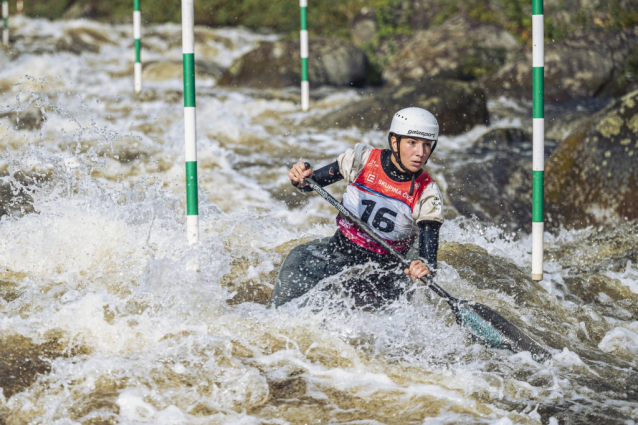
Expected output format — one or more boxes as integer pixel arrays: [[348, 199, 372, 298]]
[[454, 301, 552, 363]]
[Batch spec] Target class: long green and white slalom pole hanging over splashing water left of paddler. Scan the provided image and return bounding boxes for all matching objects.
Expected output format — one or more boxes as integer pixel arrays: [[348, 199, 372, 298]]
[[182, 0, 199, 245]]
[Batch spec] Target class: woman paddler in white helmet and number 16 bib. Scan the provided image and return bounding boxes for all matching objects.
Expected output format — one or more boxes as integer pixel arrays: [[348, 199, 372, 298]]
[[271, 108, 443, 307]]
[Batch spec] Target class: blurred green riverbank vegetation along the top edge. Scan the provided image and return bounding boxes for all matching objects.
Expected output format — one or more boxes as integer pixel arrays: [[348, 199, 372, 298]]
[[25, 0, 638, 43]]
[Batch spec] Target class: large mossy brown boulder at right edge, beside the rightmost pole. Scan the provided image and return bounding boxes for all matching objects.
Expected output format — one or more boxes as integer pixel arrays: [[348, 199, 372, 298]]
[[545, 91, 638, 228]]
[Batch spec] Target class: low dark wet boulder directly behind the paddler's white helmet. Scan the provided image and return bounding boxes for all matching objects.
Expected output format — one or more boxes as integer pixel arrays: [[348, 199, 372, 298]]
[[314, 79, 489, 134]]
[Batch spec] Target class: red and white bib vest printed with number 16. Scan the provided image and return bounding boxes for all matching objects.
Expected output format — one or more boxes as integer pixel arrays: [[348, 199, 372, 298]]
[[337, 149, 434, 255]]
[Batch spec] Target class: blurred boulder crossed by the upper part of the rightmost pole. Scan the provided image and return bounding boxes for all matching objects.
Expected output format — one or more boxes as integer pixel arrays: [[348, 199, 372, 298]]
[[481, 26, 638, 102]]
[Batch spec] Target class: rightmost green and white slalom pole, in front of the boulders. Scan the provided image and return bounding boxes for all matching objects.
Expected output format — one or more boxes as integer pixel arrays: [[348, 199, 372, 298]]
[[532, 0, 545, 280]]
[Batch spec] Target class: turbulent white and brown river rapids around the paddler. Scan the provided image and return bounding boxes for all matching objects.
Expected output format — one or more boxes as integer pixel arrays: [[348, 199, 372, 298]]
[[0, 16, 638, 424]]
